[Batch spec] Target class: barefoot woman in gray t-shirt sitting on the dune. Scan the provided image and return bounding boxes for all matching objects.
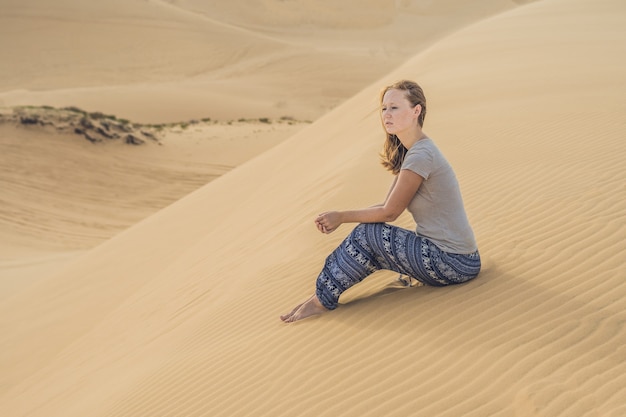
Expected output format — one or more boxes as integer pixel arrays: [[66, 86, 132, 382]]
[[281, 81, 480, 322]]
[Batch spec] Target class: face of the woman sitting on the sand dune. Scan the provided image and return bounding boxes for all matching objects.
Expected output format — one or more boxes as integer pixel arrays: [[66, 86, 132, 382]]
[[380, 89, 422, 135]]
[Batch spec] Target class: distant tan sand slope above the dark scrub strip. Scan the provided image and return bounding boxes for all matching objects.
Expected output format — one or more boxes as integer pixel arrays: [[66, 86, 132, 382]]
[[0, 0, 516, 123]]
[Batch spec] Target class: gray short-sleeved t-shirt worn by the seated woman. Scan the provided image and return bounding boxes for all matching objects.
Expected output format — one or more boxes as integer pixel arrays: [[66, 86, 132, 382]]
[[401, 138, 477, 254]]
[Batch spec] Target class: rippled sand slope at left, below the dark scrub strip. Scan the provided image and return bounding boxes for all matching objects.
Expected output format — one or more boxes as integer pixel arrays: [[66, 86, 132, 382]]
[[0, 117, 307, 299]]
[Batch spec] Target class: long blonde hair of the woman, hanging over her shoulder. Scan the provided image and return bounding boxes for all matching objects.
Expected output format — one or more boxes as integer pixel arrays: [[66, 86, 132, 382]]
[[380, 80, 426, 175]]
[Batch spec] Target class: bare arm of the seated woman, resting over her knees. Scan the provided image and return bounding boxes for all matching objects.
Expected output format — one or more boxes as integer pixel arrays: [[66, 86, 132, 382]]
[[315, 169, 424, 233]]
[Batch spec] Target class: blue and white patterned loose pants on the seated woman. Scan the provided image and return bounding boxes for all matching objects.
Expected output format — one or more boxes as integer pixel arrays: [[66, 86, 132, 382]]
[[316, 223, 480, 310]]
